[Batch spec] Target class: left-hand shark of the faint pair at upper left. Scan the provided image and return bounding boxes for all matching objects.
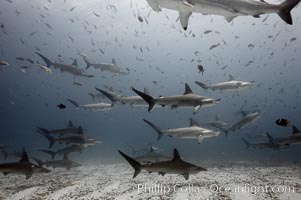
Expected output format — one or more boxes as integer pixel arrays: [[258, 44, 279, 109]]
[[36, 52, 94, 77]]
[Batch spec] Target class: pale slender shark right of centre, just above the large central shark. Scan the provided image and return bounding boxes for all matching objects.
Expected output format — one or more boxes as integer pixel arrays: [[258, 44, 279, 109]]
[[195, 75, 255, 90]]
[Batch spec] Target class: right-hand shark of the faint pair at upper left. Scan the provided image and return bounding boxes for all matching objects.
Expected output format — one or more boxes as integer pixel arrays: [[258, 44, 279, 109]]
[[80, 54, 129, 75]]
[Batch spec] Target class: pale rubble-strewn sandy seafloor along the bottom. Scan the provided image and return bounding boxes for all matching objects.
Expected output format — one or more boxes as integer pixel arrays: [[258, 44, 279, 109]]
[[0, 163, 301, 200]]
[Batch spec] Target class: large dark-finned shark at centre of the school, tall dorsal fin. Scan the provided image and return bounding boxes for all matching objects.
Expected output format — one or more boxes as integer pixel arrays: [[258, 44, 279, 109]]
[[132, 83, 220, 114]]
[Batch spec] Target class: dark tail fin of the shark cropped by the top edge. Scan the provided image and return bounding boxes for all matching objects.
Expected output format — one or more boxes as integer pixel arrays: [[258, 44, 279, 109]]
[[278, 0, 301, 24]]
